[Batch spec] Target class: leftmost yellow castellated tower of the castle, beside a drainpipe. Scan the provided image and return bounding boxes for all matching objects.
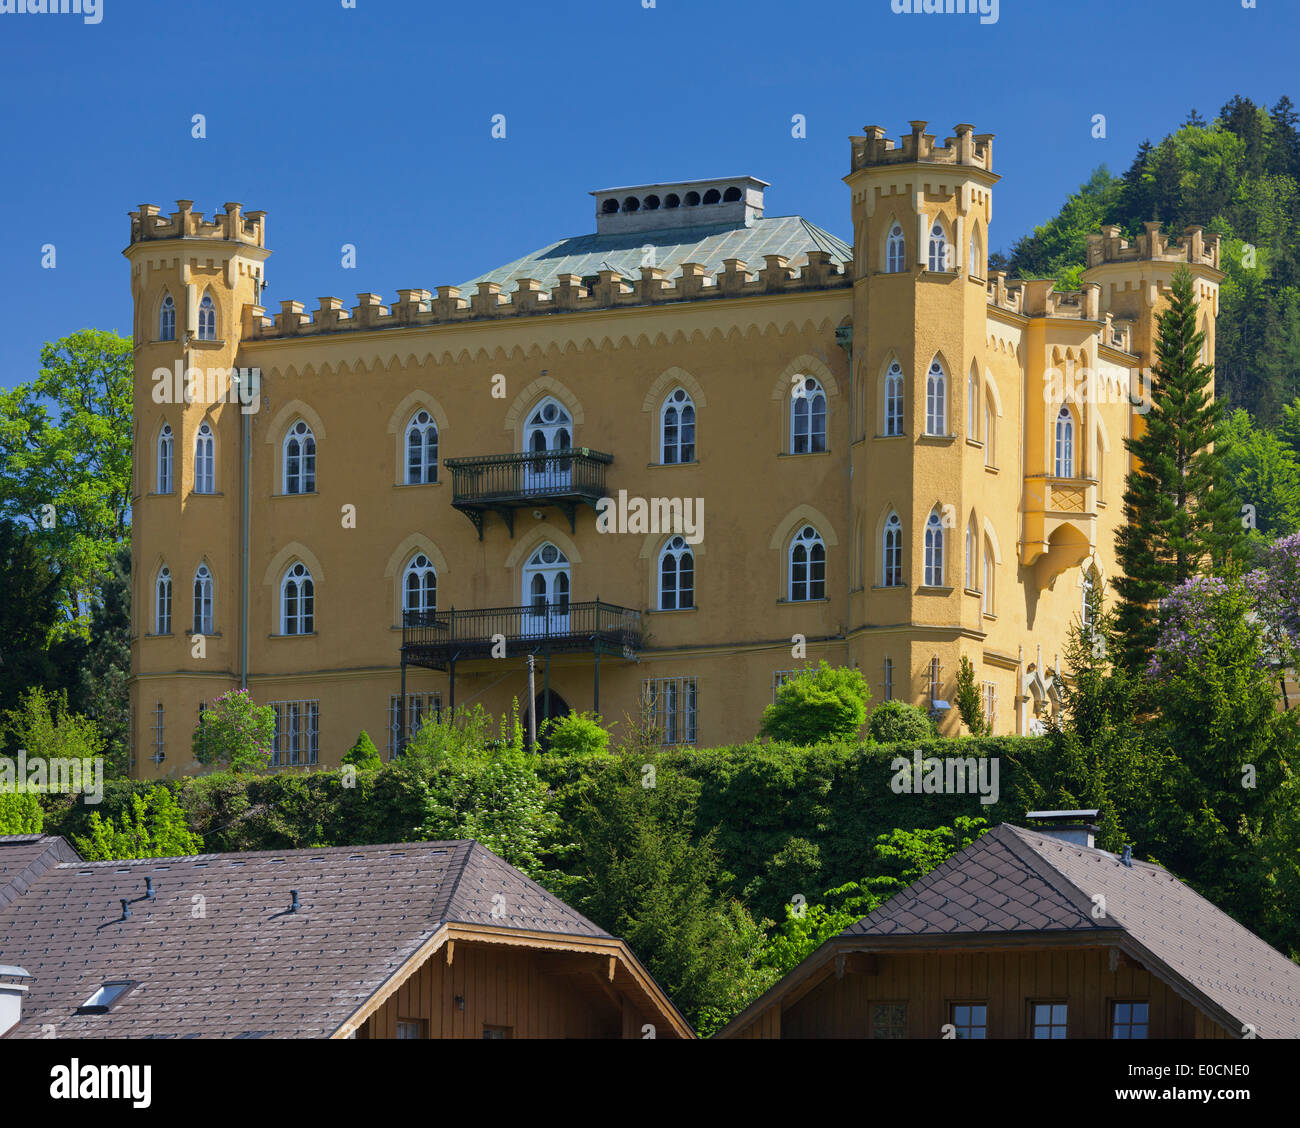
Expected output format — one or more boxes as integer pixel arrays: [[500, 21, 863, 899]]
[[124, 200, 270, 771]]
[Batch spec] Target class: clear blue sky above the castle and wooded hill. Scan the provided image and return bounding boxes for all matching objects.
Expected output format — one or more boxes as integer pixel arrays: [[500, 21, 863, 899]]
[[0, 0, 1300, 386]]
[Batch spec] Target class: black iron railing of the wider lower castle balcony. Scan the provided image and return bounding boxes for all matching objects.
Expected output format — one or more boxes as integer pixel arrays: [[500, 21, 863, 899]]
[[402, 599, 641, 667]]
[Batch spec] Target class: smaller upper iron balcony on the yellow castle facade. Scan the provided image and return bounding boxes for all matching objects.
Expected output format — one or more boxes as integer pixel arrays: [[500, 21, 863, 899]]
[[445, 447, 614, 541]]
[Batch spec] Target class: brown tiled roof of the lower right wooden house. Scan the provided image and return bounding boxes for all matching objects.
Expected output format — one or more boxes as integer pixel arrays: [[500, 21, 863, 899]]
[[841, 823, 1300, 1038]]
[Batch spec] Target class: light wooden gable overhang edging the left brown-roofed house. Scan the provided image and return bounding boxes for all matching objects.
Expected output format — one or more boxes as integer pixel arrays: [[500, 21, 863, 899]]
[[329, 923, 697, 1038]]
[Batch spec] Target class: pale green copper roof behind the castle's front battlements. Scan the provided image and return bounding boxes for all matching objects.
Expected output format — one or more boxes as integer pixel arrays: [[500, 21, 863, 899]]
[[460, 216, 853, 296]]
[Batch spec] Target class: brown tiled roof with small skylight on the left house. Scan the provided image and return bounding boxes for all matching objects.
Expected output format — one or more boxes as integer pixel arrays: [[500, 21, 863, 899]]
[[0, 836, 612, 1037]]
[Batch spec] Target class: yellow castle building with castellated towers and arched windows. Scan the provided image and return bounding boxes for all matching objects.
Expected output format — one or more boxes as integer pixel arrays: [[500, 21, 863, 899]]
[[125, 122, 1223, 777]]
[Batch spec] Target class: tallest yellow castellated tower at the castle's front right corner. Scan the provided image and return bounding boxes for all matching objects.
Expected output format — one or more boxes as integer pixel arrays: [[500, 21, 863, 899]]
[[845, 121, 998, 712]]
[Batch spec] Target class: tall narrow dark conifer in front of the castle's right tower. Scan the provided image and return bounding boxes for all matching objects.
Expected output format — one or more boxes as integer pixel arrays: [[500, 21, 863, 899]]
[[1115, 266, 1244, 672]]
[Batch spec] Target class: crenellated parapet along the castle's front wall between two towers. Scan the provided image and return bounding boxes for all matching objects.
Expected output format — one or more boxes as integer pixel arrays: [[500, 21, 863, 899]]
[[251, 251, 853, 339]]
